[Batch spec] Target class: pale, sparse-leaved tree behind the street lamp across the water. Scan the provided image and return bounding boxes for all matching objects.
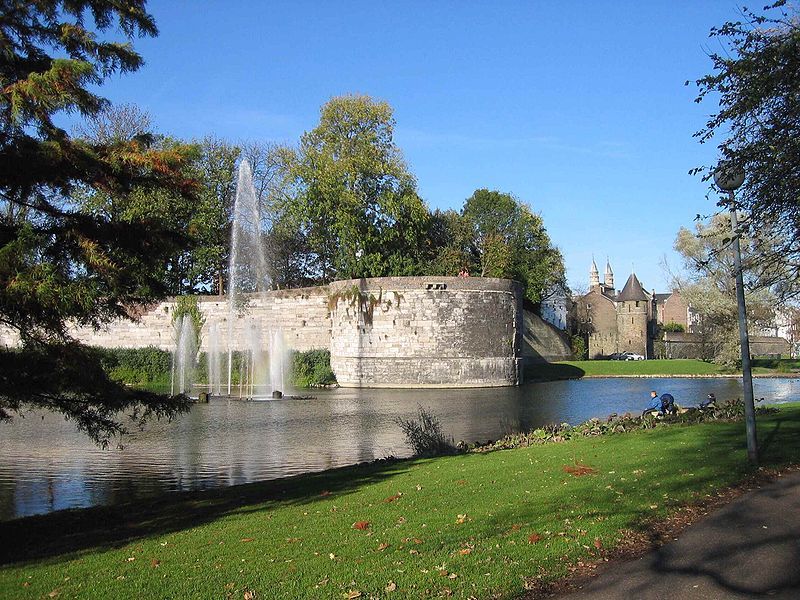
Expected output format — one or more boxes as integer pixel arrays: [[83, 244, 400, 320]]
[[674, 213, 776, 366]]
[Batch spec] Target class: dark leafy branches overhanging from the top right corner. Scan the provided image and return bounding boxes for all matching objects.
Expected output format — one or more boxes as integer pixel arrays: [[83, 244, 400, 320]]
[[687, 0, 800, 297]]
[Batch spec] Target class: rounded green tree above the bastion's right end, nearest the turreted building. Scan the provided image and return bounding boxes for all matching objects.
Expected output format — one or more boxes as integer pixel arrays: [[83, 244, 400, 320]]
[[461, 189, 566, 304]]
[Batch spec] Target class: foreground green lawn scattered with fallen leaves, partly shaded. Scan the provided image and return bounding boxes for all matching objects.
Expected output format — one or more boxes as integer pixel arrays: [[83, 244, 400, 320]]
[[0, 405, 800, 599]]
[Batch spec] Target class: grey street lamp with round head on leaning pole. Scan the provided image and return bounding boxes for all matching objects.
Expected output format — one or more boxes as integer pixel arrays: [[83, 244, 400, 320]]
[[714, 163, 758, 465]]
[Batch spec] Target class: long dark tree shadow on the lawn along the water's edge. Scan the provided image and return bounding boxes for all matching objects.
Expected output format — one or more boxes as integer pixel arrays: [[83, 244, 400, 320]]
[[0, 459, 417, 565]]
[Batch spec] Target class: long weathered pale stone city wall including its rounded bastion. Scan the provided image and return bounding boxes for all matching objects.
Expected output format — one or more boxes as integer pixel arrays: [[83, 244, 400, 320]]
[[1, 277, 569, 387]]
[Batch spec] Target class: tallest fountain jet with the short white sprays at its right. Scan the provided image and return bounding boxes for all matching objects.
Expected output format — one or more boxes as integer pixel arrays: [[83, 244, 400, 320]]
[[228, 160, 288, 399]]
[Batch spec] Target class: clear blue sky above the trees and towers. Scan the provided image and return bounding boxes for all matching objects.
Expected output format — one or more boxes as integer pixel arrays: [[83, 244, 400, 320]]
[[90, 0, 738, 292]]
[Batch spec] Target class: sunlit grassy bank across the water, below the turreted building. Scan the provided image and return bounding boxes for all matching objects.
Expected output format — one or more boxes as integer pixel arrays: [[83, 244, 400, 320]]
[[525, 359, 800, 380]]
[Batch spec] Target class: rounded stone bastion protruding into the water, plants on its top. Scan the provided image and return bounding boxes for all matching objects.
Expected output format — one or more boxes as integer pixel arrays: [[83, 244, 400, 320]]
[[329, 277, 522, 387]]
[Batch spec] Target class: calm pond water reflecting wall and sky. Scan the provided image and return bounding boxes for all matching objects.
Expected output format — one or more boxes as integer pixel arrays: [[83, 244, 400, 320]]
[[0, 379, 800, 519]]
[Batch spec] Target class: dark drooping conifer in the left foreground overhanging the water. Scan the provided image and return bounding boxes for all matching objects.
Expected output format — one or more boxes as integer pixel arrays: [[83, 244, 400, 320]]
[[0, 0, 195, 443]]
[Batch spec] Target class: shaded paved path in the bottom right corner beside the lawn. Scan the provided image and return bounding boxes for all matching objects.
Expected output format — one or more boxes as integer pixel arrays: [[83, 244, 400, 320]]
[[561, 473, 800, 600]]
